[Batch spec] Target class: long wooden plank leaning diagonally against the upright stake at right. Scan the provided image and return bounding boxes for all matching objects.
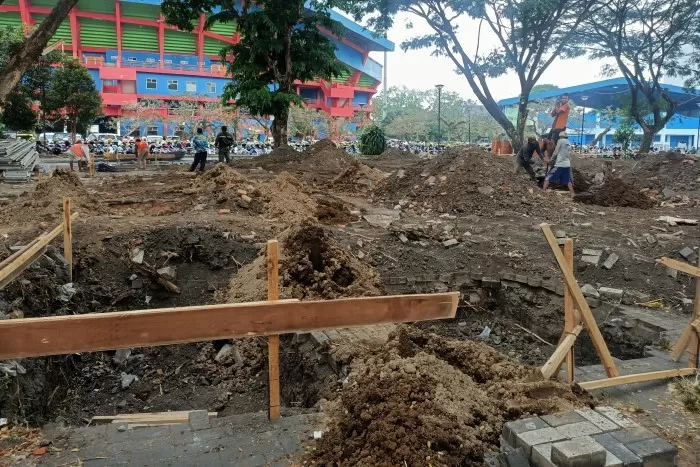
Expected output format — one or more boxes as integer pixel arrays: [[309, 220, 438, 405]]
[[540, 224, 619, 377]]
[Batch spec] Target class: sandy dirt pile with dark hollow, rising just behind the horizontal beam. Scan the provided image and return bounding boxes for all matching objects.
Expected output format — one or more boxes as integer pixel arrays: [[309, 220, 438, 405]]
[[228, 219, 384, 302]]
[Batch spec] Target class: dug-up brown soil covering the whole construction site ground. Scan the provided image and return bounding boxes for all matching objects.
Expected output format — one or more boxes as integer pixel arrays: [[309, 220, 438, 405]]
[[0, 149, 700, 465]]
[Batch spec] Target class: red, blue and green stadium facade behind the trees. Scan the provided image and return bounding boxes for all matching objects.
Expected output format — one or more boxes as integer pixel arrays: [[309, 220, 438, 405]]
[[0, 0, 394, 135]]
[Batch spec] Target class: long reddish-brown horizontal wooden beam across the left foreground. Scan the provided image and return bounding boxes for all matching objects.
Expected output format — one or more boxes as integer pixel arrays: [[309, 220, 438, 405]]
[[0, 292, 459, 360]]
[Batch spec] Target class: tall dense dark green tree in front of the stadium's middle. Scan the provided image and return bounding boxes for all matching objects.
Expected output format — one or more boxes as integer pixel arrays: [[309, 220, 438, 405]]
[[161, 0, 344, 146]]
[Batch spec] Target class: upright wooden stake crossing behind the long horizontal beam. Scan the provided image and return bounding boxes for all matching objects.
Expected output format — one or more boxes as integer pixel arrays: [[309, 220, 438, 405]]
[[267, 240, 280, 420]]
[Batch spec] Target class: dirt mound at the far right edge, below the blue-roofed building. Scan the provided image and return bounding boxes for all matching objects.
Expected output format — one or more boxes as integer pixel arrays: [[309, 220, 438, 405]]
[[621, 151, 700, 192]]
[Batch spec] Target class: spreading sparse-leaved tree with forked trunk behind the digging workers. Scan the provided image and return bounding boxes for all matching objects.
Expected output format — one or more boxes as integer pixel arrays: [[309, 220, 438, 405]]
[[354, 0, 597, 151]]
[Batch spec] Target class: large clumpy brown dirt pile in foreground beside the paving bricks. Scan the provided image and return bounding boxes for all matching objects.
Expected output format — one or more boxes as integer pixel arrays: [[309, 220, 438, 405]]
[[306, 326, 588, 466]]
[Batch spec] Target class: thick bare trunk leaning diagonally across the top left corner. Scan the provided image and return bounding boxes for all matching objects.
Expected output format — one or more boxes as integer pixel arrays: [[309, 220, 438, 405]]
[[0, 0, 78, 104]]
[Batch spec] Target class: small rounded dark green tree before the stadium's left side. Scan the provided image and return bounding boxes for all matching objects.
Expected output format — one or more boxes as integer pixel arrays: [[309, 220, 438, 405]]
[[46, 60, 102, 137]]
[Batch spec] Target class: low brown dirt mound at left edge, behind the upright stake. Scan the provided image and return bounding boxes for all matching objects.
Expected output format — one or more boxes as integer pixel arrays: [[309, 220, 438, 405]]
[[0, 169, 104, 228]]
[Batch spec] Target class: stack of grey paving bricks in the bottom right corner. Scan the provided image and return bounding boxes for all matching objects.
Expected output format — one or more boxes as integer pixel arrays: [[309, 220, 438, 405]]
[[500, 407, 678, 467]]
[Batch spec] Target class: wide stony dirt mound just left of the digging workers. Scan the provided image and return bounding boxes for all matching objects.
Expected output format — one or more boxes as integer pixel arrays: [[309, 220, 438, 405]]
[[375, 147, 559, 215]]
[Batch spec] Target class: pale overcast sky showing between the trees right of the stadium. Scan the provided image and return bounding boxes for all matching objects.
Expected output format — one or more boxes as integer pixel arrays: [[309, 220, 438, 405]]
[[370, 14, 616, 100]]
